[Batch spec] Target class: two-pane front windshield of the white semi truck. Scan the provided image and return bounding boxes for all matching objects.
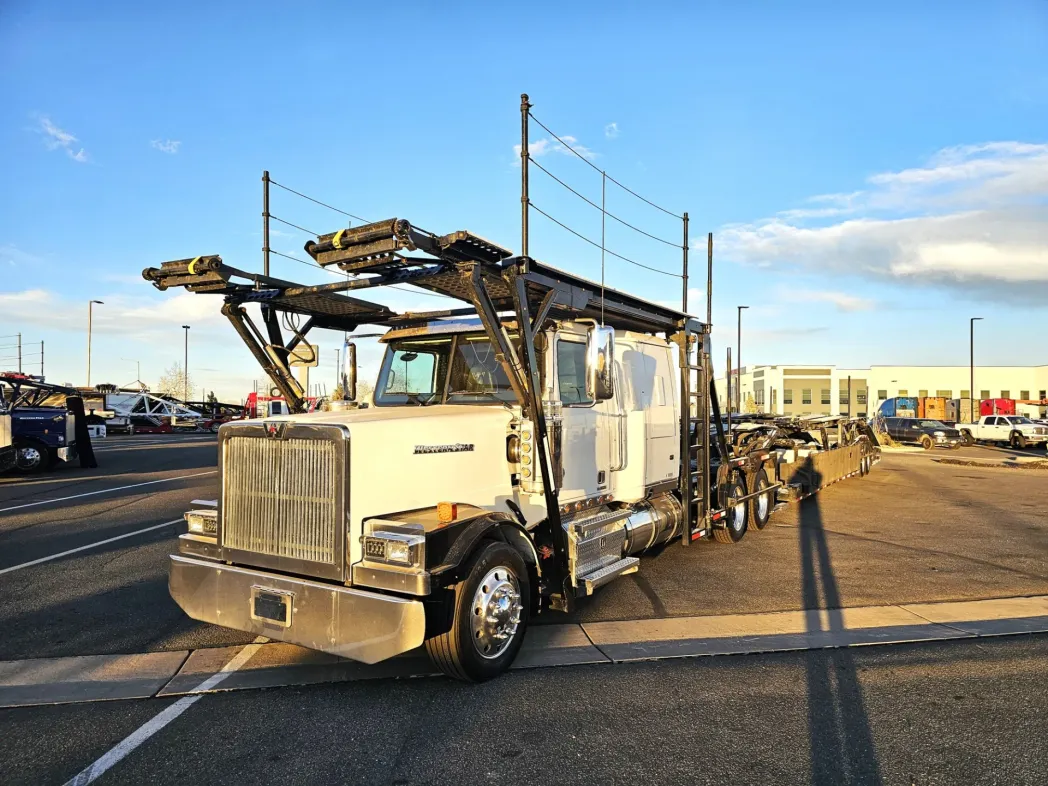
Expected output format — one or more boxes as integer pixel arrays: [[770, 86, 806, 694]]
[[375, 333, 517, 407]]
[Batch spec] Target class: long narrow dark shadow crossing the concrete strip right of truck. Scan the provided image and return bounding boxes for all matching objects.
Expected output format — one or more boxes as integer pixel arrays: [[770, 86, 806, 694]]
[[798, 458, 882, 786]]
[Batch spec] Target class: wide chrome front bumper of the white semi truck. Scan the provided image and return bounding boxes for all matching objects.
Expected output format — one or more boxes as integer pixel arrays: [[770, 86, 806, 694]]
[[168, 554, 425, 663]]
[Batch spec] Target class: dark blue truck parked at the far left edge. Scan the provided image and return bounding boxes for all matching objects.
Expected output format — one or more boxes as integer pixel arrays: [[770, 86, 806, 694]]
[[0, 374, 80, 473]]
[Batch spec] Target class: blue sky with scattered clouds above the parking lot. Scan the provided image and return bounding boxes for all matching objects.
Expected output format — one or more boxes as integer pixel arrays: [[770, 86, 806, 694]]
[[0, 0, 1048, 398]]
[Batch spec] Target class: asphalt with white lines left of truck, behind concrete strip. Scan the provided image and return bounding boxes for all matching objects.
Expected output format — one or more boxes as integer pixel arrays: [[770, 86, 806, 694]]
[[0, 435, 250, 660]]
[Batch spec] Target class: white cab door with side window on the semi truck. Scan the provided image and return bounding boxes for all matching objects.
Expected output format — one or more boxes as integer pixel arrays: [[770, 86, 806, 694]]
[[553, 331, 615, 502]]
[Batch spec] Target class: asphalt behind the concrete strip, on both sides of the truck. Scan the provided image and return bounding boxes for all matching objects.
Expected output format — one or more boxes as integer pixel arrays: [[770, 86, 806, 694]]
[[0, 435, 1048, 660]]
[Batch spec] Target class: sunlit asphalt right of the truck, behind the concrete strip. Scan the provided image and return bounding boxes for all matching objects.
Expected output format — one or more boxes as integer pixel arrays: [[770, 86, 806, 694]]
[[539, 452, 1048, 623]]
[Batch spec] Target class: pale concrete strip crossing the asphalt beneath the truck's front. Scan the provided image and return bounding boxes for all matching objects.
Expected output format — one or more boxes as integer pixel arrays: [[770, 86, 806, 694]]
[[0, 595, 1048, 707]]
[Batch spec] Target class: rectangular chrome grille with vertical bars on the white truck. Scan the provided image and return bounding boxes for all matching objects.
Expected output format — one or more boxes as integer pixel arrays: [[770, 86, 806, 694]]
[[221, 436, 341, 564]]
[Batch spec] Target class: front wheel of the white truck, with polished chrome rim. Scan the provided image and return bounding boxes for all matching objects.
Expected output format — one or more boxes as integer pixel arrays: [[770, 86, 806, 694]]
[[425, 541, 531, 682]]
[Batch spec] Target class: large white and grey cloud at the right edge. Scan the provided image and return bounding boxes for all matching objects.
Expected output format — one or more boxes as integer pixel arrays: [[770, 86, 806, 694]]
[[720, 141, 1048, 305]]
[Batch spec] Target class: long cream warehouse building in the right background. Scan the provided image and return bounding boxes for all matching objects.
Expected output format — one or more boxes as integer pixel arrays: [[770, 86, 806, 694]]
[[717, 364, 1048, 415]]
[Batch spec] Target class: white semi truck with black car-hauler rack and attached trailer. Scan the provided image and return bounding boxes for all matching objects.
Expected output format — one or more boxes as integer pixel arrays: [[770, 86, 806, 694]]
[[144, 219, 879, 681]]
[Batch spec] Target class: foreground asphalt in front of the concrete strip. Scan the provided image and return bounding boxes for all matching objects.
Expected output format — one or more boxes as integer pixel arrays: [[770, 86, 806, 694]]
[[0, 636, 1048, 786]]
